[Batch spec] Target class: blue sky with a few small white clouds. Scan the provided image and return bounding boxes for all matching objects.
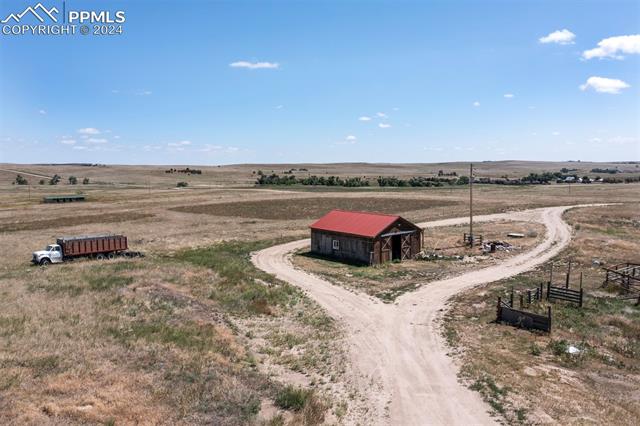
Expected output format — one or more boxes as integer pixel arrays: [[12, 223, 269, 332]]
[[0, 0, 640, 165]]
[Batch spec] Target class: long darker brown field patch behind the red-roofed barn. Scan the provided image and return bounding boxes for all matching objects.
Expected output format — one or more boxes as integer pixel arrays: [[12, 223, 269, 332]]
[[170, 197, 458, 220]]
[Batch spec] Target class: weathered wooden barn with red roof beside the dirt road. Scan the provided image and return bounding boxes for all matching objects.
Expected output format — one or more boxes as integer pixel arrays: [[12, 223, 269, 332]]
[[310, 210, 423, 265]]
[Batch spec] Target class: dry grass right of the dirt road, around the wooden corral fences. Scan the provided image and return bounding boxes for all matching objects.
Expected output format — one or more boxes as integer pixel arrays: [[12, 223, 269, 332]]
[[445, 203, 640, 424]]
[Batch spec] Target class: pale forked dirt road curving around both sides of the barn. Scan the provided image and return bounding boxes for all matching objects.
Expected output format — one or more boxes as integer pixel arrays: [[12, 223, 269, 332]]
[[252, 207, 571, 425]]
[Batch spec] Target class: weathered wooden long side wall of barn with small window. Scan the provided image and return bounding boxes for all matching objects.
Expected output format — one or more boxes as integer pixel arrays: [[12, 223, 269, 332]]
[[311, 230, 372, 264]]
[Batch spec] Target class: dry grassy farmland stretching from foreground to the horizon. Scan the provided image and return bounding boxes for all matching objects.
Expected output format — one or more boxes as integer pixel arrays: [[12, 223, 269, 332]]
[[0, 162, 640, 425]]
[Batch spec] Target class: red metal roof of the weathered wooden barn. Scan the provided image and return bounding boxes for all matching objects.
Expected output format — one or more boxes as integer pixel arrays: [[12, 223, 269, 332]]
[[310, 210, 400, 238]]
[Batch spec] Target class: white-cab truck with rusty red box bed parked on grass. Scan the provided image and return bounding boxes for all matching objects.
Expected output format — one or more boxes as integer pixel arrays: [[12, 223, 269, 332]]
[[31, 235, 142, 265]]
